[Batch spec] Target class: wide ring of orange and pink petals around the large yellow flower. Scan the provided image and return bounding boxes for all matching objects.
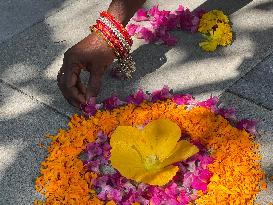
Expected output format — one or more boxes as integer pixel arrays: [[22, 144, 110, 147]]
[[35, 86, 265, 205]]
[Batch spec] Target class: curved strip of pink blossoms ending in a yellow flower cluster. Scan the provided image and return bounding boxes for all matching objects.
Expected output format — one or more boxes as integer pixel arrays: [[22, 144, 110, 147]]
[[127, 5, 232, 52]]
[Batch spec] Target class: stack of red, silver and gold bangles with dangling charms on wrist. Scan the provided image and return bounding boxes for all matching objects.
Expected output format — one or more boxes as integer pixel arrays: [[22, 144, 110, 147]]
[[90, 11, 136, 78]]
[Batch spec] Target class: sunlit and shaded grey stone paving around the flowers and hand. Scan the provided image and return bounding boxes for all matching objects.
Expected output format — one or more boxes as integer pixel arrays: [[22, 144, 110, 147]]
[[0, 0, 273, 205]]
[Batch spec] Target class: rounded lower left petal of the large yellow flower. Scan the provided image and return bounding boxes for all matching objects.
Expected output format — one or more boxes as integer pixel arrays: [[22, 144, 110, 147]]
[[110, 143, 146, 180]]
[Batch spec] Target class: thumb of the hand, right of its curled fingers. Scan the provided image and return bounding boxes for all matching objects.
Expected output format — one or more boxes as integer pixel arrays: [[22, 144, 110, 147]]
[[86, 65, 103, 103]]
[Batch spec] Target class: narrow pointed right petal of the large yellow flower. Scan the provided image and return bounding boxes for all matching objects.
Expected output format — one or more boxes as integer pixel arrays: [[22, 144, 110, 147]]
[[162, 140, 199, 167]]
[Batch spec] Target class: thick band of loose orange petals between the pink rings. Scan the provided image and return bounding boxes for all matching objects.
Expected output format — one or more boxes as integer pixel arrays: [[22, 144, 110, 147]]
[[36, 100, 264, 205]]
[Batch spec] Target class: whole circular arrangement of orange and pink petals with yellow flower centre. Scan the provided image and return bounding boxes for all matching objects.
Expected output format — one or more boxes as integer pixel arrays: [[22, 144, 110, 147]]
[[35, 86, 264, 205]]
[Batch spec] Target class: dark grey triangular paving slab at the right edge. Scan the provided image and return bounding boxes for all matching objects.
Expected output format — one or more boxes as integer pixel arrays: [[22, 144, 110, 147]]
[[229, 52, 273, 110]]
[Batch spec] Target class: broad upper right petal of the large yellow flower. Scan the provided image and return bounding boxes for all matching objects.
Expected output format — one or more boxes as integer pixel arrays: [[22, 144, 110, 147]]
[[142, 119, 181, 161]]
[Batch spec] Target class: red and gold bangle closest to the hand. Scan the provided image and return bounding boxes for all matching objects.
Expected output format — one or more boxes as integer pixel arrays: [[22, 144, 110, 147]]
[[96, 21, 127, 57]]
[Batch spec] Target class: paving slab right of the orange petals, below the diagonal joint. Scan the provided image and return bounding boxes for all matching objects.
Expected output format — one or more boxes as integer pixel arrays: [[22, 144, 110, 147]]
[[220, 92, 273, 205]]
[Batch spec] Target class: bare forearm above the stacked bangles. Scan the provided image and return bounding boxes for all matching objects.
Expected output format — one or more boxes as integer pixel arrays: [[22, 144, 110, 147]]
[[108, 0, 146, 26]]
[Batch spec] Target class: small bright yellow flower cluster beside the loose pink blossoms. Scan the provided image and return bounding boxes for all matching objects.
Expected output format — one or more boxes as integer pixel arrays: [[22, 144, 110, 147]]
[[198, 10, 232, 51]]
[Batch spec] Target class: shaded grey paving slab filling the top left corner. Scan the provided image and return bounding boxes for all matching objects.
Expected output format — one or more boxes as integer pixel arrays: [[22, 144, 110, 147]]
[[0, 0, 73, 42]]
